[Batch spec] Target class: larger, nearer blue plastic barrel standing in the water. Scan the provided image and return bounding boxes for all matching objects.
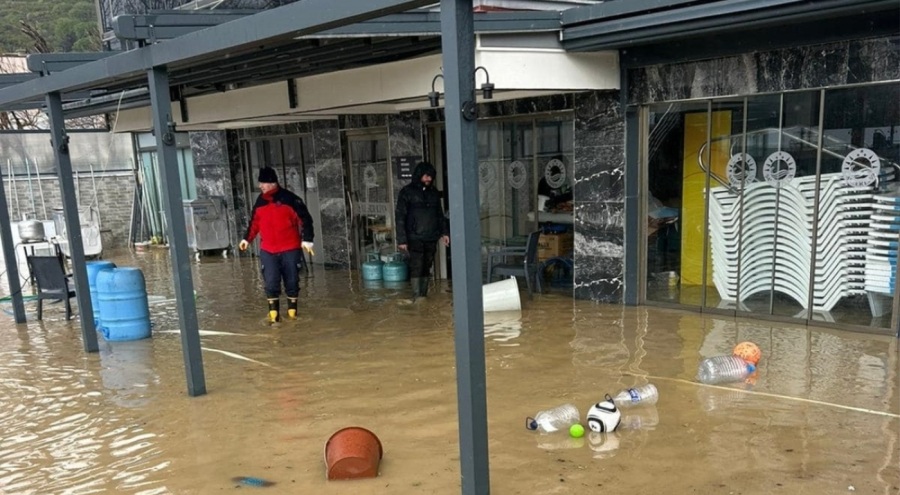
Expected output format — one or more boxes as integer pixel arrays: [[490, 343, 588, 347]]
[[97, 267, 150, 340]]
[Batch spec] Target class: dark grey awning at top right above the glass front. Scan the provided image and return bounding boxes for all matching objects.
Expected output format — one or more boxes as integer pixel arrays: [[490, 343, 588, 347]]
[[562, 0, 900, 66]]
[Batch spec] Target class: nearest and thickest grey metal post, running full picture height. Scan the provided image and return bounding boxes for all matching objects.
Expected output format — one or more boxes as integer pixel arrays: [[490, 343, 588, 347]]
[[441, 0, 491, 495]]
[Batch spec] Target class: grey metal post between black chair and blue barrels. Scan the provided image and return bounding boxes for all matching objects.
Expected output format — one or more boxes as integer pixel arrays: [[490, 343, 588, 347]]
[[47, 92, 99, 352]]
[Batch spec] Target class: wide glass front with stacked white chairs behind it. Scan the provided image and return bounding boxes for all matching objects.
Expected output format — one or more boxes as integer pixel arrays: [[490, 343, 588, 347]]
[[644, 84, 900, 334]]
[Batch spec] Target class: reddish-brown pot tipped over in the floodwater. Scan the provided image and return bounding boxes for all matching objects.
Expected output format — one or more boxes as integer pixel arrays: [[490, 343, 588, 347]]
[[325, 426, 384, 480]]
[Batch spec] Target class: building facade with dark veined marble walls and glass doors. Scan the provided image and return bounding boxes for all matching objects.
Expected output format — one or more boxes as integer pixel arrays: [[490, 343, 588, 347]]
[[82, 0, 900, 334]]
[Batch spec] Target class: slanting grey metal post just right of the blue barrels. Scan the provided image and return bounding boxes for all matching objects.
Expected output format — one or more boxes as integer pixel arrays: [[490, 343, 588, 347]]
[[147, 67, 206, 397]]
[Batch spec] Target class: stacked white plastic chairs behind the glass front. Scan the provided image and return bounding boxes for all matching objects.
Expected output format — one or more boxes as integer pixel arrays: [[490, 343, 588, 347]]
[[710, 170, 873, 311]]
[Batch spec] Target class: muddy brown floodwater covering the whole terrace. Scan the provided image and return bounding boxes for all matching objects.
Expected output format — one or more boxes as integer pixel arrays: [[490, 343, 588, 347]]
[[0, 250, 900, 495]]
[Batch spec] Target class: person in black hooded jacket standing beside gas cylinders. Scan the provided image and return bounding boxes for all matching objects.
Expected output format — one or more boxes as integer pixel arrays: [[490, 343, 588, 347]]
[[394, 162, 450, 300]]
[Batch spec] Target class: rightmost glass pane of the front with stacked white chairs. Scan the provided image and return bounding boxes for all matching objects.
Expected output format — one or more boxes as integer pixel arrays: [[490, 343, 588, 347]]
[[813, 84, 900, 328]]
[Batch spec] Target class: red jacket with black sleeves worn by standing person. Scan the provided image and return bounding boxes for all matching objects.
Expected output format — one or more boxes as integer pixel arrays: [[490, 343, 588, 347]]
[[244, 186, 315, 254]]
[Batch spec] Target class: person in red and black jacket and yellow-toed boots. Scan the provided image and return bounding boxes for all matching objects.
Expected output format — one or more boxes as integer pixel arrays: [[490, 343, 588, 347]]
[[238, 167, 314, 323]]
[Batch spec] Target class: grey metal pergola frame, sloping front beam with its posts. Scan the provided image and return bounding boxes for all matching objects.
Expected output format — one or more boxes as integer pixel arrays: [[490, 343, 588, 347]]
[[0, 0, 490, 494]]
